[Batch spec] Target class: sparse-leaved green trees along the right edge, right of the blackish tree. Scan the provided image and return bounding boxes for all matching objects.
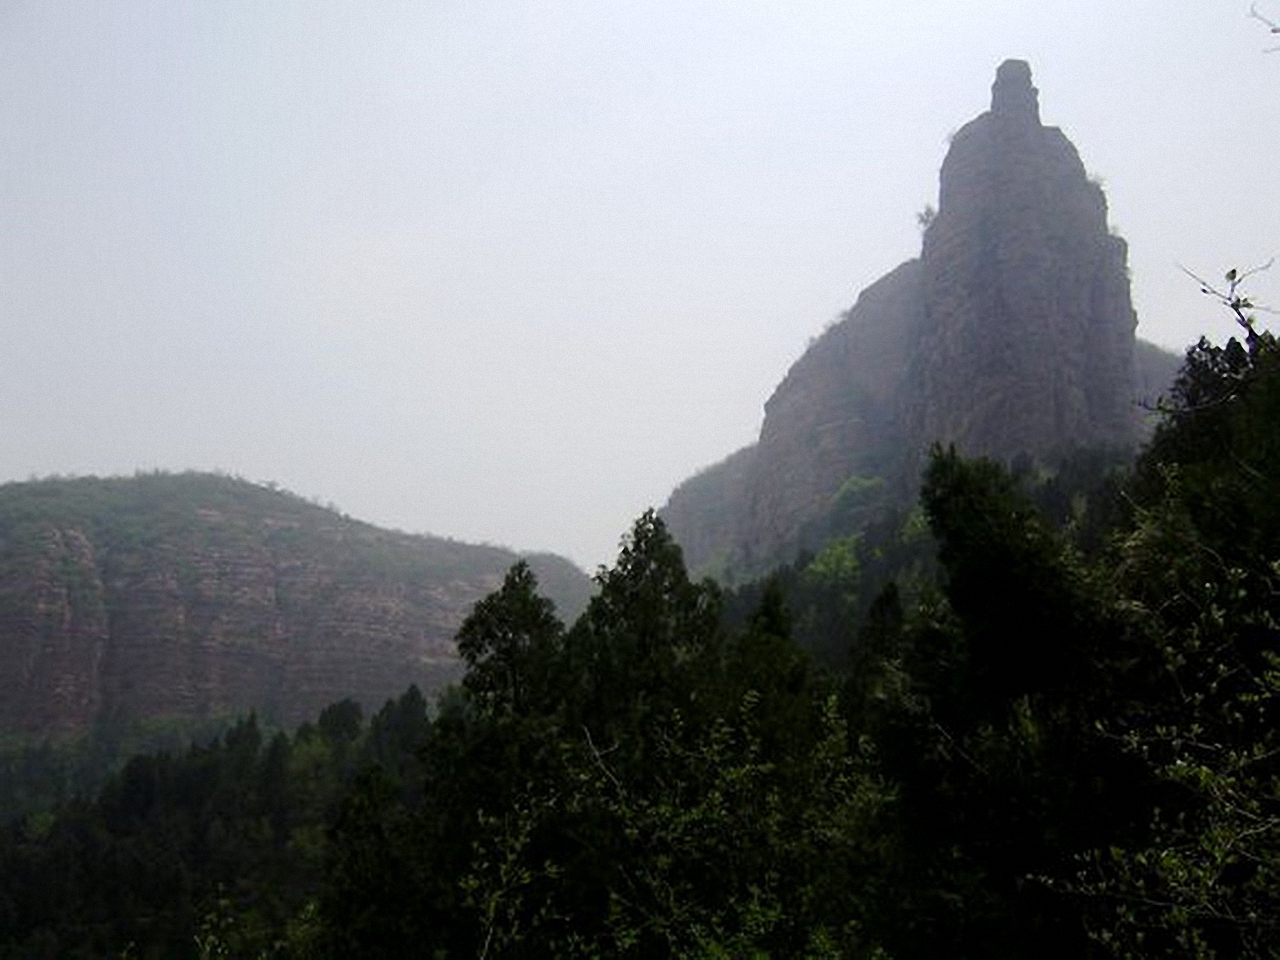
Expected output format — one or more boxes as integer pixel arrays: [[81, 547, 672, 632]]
[[1078, 334, 1280, 957]]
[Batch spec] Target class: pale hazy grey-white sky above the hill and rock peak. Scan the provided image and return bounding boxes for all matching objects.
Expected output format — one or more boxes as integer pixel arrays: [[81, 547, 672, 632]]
[[0, 0, 1280, 568]]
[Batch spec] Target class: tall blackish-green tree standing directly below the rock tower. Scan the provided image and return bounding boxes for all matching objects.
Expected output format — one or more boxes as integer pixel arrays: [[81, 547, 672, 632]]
[[849, 449, 1147, 957]]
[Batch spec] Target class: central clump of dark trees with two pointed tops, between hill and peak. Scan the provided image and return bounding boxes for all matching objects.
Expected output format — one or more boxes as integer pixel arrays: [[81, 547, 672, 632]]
[[313, 513, 888, 957]]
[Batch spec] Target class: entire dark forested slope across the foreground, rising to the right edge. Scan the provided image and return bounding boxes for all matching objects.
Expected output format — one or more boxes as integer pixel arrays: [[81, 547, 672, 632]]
[[0, 312, 1280, 960]]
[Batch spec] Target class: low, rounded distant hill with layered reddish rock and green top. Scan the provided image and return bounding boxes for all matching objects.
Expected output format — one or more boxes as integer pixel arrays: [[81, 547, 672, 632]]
[[0, 474, 591, 733]]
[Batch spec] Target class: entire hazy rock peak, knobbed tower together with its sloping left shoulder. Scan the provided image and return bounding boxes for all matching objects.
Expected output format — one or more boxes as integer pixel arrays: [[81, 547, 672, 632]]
[[664, 60, 1167, 579]]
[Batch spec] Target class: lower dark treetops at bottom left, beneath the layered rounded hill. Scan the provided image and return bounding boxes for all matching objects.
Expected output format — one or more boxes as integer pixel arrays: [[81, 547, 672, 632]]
[[0, 690, 426, 959]]
